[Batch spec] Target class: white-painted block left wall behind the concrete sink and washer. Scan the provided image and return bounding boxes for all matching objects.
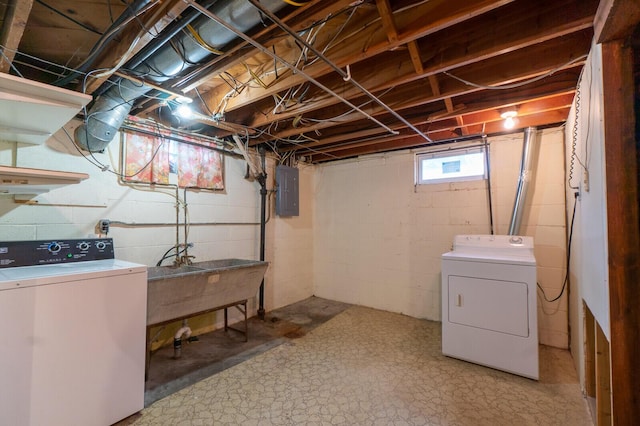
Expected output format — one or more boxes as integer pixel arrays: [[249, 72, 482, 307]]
[[0, 122, 313, 343]]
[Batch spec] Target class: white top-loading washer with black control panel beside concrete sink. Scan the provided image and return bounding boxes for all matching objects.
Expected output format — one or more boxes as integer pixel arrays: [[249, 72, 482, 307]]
[[0, 239, 147, 426]]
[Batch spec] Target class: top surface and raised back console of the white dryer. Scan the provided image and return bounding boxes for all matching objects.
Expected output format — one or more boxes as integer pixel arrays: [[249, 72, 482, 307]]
[[442, 235, 536, 265]]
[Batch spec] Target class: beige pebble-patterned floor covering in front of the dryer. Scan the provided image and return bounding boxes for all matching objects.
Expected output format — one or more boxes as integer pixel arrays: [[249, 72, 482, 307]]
[[121, 306, 592, 426]]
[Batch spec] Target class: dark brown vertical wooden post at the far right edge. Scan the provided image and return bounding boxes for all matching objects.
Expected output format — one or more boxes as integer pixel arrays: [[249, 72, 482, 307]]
[[602, 41, 640, 425]]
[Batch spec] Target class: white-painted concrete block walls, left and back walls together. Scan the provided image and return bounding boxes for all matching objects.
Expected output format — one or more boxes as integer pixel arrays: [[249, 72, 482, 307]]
[[0, 118, 567, 347]]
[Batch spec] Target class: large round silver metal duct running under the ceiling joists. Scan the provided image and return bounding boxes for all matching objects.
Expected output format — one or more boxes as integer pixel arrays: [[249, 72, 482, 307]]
[[75, 0, 286, 152]]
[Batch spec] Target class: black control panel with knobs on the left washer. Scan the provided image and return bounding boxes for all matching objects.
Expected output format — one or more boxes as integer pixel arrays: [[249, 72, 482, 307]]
[[0, 238, 114, 268]]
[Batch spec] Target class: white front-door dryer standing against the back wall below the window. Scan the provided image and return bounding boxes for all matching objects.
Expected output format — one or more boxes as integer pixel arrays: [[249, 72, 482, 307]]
[[442, 235, 538, 380]]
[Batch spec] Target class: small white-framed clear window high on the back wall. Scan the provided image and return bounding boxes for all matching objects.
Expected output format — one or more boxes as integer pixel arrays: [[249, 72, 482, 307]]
[[416, 147, 486, 185]]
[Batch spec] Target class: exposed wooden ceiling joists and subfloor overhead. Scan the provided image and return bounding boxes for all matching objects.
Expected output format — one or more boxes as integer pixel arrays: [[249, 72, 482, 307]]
[[0, 0, 599, 162]]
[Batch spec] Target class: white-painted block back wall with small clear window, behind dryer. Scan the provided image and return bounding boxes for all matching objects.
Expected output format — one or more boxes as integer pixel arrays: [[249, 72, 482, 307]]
[[314, 129, 568, 348]]
